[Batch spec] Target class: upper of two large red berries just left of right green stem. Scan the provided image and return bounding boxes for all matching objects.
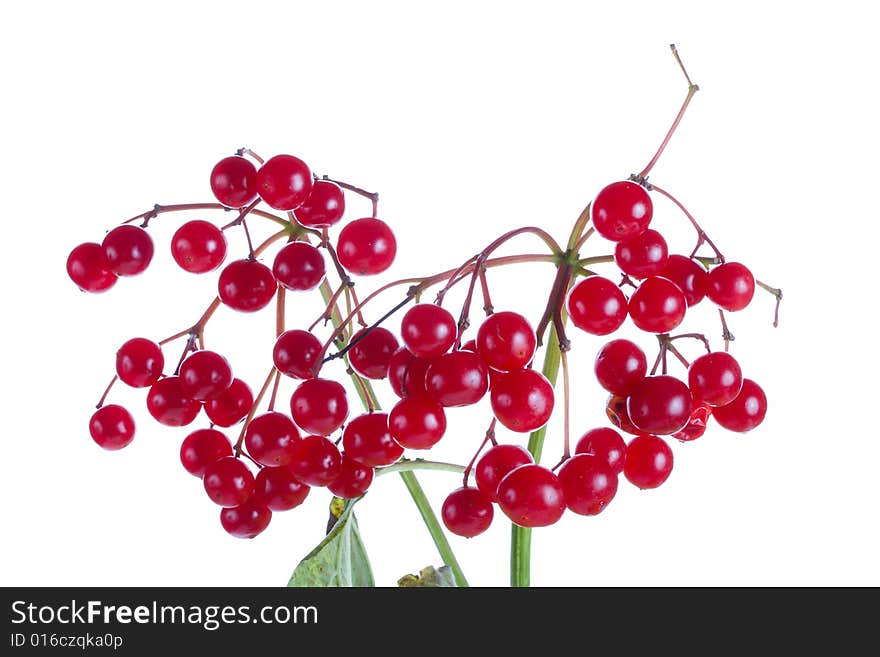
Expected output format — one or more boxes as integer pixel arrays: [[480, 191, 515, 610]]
[[475, 311, 537, 372]]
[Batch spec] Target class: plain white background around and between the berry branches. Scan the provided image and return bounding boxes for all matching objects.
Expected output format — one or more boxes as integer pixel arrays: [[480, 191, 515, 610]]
[[0, 2, 880, 586]]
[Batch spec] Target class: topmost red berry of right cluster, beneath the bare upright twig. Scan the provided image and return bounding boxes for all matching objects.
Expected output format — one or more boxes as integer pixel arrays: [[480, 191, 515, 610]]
[[591, 180, 654, 242]]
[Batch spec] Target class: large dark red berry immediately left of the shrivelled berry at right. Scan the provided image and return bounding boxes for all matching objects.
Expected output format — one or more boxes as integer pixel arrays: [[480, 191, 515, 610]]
[[626, 374, 693, 435]]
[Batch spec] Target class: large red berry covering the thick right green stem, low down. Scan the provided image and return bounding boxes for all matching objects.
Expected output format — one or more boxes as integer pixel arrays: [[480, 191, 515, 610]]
[[498, 463, 565, 527]]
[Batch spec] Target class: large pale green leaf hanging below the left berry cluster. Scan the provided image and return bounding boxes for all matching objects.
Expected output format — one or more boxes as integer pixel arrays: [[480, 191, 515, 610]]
[[287, 500, 375, 587]]
